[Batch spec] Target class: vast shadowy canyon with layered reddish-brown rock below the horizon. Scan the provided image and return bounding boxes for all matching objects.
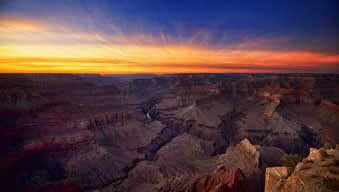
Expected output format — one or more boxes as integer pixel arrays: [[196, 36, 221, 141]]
[[0, 74, 339, 192]]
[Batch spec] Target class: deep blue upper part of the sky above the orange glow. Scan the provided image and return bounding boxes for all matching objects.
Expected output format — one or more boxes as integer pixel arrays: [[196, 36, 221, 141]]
[[1, 0, 338, 50]]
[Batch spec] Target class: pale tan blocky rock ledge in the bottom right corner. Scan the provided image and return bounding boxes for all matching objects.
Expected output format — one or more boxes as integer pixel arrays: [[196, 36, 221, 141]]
[[265, 148, 339, 192]]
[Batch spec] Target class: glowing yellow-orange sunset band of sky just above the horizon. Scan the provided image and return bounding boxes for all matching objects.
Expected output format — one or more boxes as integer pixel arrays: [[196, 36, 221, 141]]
[[0, 18, 339, 74]]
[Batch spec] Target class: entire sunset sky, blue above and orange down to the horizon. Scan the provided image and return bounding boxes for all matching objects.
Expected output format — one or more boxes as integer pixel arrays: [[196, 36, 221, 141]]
[[0, 0, 339, 74]]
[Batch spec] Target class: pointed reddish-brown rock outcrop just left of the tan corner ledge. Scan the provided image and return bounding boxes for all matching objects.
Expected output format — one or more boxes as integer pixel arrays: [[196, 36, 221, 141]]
[[155, 139, 263, 192]]
